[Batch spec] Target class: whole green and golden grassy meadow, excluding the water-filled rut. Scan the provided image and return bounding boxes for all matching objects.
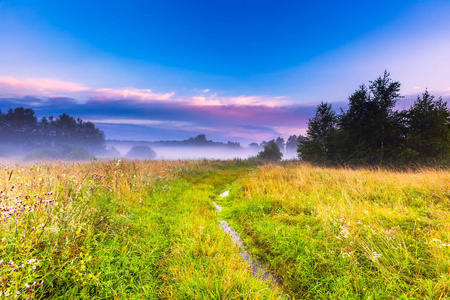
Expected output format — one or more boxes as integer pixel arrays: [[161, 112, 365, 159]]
[[0, 160, 450, 299]]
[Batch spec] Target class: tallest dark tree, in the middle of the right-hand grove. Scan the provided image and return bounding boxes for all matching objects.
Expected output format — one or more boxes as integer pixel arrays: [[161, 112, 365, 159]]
[[334, 71, 405, 164]]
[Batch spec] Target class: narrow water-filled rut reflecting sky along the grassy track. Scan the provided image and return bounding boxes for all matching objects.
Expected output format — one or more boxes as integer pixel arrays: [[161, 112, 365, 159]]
[[212, 190, 278, 286]]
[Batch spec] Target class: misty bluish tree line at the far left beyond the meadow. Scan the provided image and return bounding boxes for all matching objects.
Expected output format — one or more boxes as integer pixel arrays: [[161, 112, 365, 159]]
[[0, 107, 105, 152]]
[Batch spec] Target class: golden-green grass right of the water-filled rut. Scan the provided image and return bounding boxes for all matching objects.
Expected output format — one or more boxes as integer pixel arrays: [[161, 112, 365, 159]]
[[222, 163, 450, 299]]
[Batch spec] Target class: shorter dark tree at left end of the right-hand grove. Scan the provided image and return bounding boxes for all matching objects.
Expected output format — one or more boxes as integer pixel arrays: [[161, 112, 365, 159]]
[[297, 102, 337, 163]]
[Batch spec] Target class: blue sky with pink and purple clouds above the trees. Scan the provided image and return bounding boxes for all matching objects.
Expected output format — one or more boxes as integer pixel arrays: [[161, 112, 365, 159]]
[[0, 0, 450, 145]]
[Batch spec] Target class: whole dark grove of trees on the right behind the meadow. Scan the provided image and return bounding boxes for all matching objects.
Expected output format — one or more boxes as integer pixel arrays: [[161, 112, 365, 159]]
[[298, 71, 450, 166]]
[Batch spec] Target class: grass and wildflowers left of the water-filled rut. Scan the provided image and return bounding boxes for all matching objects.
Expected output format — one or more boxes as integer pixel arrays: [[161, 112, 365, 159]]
[[0, 161, 281, 299]]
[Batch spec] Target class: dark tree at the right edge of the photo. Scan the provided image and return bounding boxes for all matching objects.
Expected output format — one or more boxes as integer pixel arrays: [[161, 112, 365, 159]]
[[406, 90, 450, 162]]
